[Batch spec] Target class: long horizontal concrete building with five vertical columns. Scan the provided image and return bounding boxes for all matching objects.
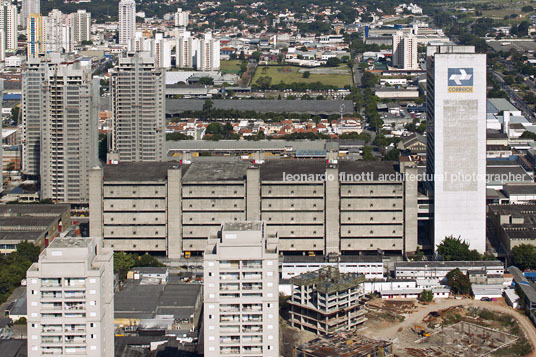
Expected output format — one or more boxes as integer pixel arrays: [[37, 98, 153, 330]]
[[90, 158, 417, 258]]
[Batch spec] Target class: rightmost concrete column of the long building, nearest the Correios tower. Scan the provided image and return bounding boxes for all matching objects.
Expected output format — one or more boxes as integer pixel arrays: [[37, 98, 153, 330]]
[[403, 167, 418, 254]]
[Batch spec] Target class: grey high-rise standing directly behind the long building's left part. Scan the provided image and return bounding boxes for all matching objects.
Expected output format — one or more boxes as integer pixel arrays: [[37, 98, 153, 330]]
[[110, 52, 166, 161]]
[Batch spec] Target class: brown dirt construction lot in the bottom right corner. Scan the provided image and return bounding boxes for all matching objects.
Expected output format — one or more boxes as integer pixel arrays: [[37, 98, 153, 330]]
[[362, 299, 536, 357]]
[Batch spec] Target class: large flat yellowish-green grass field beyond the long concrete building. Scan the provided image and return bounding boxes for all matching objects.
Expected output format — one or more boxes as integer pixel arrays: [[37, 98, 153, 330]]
[[252, 64, 352, 88]]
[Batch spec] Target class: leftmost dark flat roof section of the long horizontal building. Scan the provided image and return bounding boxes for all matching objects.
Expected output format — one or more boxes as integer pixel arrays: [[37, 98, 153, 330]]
[[103, 162, 179, 182]]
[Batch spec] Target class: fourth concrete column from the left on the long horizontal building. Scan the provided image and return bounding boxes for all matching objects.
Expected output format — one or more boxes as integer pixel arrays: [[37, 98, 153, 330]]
[[324, 164, 340, 255]]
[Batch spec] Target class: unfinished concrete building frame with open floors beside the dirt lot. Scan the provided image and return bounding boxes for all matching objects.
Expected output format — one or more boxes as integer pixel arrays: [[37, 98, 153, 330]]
[[289, 267, 367, 335]]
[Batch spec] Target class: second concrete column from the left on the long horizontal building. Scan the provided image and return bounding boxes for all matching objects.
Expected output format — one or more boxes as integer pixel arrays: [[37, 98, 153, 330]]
[[167, 167, 182, 259]]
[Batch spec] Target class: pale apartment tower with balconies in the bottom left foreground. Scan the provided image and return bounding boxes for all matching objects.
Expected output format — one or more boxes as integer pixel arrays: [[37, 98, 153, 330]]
[[26, 237, 114, 357]]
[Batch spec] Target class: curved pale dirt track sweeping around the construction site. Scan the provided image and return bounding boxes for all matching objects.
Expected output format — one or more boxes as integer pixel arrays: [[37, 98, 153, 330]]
[[366, 299, 536, 357]]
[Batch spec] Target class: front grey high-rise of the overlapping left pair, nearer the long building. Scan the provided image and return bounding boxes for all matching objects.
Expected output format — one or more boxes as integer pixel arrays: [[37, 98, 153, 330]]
[[39, 62, 100, 203]]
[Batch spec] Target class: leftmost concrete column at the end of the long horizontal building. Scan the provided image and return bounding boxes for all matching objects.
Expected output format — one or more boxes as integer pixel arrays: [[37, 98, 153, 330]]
[[89, 167, 104, 247]]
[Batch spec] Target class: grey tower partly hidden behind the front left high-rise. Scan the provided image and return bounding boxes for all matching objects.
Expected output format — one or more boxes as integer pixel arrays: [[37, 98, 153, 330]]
[[21, 54, 62, 177]]
